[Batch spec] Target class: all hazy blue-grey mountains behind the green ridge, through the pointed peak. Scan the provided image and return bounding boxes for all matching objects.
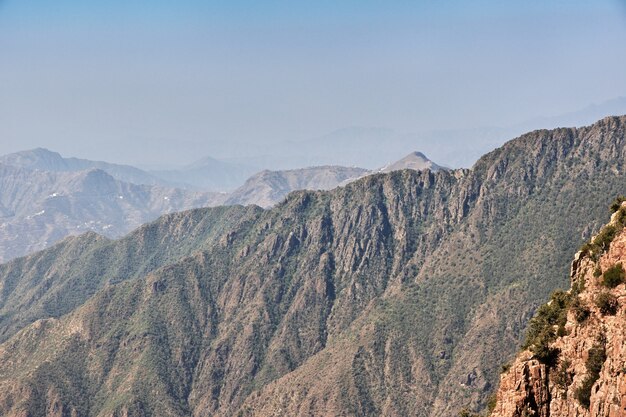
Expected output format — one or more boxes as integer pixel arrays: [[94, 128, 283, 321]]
[[0, 149, 437, 261]]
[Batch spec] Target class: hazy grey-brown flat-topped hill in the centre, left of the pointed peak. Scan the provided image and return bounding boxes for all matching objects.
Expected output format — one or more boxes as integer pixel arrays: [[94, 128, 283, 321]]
[[226, 166, 370, 207]]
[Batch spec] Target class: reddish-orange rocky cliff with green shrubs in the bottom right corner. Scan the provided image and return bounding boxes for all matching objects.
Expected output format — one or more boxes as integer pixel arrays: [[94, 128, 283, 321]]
[[491, 205, 626, 417]]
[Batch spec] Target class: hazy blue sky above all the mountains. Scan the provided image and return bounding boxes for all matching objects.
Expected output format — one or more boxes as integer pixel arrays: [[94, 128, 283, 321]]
[[0, 0, 626, 163]]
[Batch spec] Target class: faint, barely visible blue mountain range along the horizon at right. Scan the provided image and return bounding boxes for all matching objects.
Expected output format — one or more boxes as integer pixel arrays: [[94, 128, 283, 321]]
[[191, 97, 626, 169]]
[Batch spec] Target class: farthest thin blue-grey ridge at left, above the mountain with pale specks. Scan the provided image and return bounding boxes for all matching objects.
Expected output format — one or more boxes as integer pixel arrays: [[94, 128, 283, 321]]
[[0, 148, 171, 186]]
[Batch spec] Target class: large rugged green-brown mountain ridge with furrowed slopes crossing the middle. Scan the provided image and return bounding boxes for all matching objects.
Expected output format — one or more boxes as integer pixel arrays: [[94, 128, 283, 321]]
[[0, 117, 626, 417]]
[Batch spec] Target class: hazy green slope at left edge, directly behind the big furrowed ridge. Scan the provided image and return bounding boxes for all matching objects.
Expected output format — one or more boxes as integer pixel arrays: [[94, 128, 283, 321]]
[[0, 207, 261, 341]]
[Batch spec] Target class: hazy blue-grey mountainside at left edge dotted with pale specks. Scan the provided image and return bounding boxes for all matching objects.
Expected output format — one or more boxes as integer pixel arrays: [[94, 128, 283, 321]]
[[0, 164, 223, 261]]
